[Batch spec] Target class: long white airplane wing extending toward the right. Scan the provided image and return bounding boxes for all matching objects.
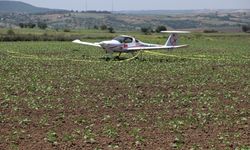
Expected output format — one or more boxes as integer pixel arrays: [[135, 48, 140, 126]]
[[126, 45, 188, 51]]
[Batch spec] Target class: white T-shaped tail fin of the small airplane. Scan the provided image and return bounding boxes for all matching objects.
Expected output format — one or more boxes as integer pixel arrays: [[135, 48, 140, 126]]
[[161, 31, 190, 46]]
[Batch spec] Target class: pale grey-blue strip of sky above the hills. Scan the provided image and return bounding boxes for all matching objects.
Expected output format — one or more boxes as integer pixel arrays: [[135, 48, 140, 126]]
[[5, 0, 250, 11]]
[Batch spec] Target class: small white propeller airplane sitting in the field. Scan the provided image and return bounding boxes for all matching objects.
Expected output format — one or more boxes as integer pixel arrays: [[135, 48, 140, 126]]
[[72, 31, 190, 58]]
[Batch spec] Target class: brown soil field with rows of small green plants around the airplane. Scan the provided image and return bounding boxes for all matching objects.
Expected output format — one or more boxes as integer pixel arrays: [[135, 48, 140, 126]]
[[0, 33, 250, 150]]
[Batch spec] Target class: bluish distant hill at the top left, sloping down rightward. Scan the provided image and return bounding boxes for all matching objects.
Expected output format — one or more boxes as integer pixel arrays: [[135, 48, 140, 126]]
[[0, 1, 65, 13]]
